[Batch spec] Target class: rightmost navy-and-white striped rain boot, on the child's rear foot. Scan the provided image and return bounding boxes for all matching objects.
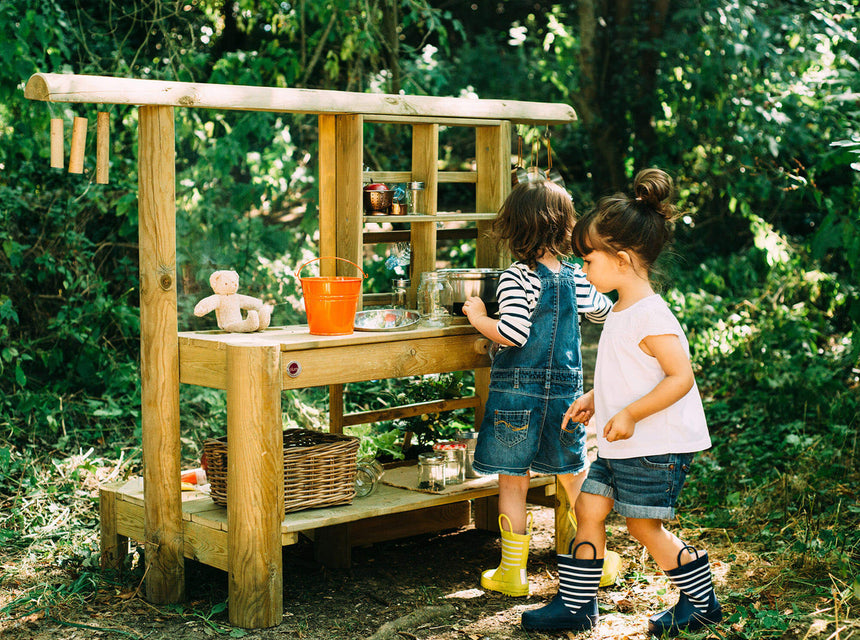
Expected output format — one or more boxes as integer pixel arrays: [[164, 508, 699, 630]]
[[648, 545, 723, 636]]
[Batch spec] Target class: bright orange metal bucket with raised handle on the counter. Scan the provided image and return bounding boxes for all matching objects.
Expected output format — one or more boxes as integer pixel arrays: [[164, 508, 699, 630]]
[[296, 256, 367, 336]]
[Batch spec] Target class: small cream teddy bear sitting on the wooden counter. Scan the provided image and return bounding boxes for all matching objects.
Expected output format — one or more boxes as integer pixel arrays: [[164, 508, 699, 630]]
[[194, 270, 272, 333]]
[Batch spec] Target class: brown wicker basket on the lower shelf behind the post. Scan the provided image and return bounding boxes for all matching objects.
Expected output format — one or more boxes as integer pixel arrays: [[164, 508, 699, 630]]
[[203, 429, 358, 513]]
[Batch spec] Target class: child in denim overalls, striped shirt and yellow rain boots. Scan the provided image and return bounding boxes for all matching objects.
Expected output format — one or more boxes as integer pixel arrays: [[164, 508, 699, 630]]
[[463, 180, 620, 596]]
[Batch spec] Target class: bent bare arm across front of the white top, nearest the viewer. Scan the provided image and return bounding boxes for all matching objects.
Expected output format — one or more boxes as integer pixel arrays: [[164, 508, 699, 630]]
[[603, 334, 695, 442]]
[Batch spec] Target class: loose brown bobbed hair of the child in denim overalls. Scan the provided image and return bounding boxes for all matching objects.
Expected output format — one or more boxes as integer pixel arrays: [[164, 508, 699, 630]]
[[491, 180, 576, 269]]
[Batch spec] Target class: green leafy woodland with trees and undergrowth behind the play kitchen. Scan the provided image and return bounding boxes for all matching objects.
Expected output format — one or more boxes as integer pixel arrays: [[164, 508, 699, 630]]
[[0, 0, 860, 637]]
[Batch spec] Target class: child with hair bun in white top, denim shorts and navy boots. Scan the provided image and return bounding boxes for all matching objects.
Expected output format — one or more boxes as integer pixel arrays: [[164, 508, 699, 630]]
[[522, 169, 722, 636]]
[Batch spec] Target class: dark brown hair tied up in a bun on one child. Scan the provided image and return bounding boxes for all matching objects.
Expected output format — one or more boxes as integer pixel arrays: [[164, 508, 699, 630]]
[[571, 169, 677, 273]]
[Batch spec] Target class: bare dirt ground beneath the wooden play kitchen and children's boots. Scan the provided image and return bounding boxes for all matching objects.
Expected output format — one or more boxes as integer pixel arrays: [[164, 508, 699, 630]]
[[0, 507, 812, 640]]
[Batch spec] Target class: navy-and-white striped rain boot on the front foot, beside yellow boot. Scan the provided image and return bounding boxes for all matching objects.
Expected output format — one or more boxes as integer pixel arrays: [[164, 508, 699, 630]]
[[522, 541, 603, 631]]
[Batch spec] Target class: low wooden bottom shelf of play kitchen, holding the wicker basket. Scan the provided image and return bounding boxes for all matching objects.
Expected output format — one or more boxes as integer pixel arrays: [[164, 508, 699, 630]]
[[100, 476, 555, 571]]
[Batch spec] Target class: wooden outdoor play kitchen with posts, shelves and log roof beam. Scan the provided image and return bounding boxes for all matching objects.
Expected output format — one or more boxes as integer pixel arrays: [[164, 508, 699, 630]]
[[25, 73, 576, 628]]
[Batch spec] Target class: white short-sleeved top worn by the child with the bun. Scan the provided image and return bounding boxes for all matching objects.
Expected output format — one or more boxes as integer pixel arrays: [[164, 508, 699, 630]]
[[592, 294, 711, 459]]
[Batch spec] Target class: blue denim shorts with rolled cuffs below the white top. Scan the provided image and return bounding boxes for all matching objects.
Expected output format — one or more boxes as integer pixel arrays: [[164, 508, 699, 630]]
[[582, 453, 695, 520]]
